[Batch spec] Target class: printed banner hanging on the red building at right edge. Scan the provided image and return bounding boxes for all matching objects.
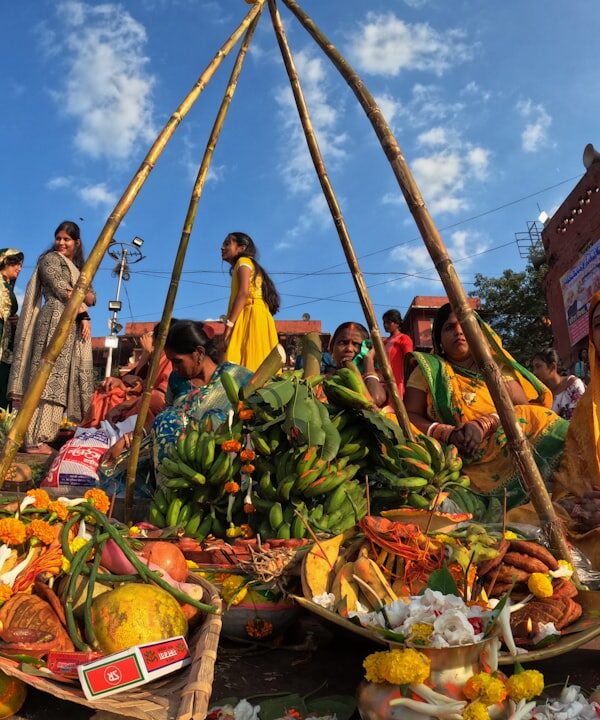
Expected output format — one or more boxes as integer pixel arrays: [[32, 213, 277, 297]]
[[560, 240, 600, 345]]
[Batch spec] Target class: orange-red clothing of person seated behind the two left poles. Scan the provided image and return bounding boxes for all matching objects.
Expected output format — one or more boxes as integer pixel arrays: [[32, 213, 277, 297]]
[[81, 353, 173, 427]]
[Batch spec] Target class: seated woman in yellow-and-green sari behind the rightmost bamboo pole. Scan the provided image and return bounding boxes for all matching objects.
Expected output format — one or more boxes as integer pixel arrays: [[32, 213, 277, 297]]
[[404, 304, 569, 509]]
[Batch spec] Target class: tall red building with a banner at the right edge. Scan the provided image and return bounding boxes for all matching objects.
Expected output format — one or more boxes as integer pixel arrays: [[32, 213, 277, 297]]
[[542, 151, 600, 367]]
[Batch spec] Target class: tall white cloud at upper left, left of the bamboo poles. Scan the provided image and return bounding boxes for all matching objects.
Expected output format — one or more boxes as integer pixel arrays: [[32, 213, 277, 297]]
[[48, 0, 155, 160]]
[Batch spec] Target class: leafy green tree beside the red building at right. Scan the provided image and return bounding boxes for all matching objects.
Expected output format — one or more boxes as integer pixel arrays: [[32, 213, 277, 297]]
[[470, 263, 553, 364]]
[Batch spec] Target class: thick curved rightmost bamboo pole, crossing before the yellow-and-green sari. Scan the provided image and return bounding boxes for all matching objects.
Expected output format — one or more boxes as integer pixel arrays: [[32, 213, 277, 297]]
[[283, 0, 571, 561]]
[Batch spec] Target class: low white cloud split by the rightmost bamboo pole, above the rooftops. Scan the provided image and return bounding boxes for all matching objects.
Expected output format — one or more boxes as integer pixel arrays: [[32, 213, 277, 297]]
[[389, 230, 489, 287]]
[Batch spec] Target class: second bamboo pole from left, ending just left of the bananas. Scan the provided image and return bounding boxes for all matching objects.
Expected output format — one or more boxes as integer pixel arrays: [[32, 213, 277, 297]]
[[125, 11, 262, 522]]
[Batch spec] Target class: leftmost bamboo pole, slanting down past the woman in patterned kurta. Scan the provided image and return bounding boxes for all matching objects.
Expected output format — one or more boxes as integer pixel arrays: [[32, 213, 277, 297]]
[[0, 0, 265, 488]]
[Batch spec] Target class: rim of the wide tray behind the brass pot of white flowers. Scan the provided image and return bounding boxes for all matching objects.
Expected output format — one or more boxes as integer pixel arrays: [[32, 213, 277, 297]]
[[290, 590, 600, 665]]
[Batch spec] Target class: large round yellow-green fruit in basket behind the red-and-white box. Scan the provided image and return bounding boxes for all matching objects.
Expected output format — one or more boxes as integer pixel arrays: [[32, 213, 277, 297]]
[[91, 582, 188, 653]]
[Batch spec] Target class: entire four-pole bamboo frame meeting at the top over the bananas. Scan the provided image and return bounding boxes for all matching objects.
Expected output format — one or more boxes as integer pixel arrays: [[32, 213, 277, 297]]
[[0, 0, 570, 559]]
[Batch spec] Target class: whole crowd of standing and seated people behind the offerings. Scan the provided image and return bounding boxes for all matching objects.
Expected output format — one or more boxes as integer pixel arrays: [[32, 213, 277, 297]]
[[0, 221, 600, 566]]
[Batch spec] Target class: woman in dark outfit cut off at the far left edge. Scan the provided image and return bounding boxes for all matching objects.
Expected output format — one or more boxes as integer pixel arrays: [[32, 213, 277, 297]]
[[0, 248, 24, 408]]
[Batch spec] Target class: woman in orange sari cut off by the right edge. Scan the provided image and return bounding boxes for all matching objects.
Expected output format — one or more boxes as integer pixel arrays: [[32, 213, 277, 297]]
[[552, 292, 600, 570]]
